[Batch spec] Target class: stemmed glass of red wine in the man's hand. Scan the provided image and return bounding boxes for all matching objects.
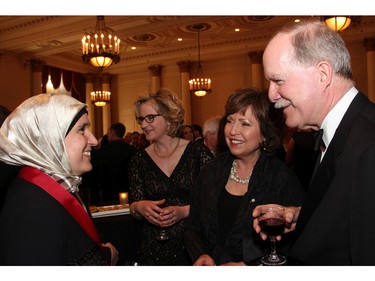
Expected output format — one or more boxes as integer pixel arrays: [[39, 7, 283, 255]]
[[258, 206, 286, 265]]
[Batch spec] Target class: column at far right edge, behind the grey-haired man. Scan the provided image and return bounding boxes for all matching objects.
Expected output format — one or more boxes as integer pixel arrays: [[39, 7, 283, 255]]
[[363, 37, 375, 102]]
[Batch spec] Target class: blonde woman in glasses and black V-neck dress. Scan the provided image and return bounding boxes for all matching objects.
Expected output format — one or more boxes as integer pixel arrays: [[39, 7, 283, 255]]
[[128, 89, 212, 265]]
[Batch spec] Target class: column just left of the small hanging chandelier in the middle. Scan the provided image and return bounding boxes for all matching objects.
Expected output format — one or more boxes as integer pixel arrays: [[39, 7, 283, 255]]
[[177, 61, 191, 124]]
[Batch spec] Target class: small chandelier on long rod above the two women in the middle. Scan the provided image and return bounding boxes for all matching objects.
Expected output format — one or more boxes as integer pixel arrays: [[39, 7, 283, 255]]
[[189, 24, 211, 97]]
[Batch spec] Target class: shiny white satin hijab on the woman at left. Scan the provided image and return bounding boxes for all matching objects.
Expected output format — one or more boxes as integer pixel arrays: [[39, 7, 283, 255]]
[[0, 94, 87, 192]]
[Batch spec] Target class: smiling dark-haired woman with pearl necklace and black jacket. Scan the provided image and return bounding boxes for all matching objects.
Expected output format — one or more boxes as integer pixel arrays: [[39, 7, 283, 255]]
[[185, 88, 303, 265]]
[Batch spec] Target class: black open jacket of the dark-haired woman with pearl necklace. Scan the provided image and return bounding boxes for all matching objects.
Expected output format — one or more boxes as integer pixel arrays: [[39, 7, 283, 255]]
[[185, 152, 304, 264]]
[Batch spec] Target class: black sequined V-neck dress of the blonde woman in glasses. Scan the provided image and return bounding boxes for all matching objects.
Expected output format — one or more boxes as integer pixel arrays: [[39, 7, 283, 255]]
[[128, 142, 212, 265]]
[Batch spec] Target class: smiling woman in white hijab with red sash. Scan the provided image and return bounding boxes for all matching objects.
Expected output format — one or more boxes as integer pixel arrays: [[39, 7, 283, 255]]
[[0, 94, 118, 265]]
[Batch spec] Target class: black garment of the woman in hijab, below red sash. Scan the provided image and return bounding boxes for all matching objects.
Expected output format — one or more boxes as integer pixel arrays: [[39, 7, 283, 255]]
[[0, 178, 107, 265]]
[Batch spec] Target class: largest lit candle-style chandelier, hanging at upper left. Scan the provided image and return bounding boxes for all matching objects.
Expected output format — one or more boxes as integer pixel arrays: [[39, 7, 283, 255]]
[[82, 16, 120, 68]]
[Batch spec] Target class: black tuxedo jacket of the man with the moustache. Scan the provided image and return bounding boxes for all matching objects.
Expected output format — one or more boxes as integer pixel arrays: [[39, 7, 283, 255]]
[[291, 92, 375, 265]]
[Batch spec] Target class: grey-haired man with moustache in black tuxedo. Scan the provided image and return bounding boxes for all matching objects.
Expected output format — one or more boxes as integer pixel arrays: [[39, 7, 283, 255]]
[[253, 21, 375, 265]]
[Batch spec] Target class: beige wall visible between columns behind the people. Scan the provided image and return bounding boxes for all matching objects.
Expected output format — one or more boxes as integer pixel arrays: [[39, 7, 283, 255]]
[[0, 41, 374, 137]]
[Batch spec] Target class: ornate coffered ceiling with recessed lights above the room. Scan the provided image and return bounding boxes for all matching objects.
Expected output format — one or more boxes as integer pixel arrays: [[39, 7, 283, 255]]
[[0, 16, 375, 73]]
